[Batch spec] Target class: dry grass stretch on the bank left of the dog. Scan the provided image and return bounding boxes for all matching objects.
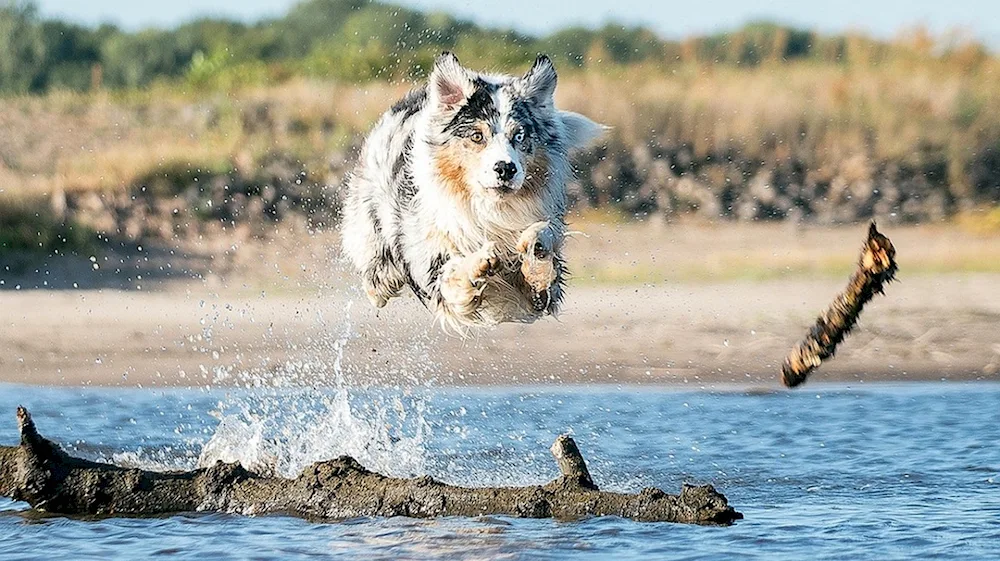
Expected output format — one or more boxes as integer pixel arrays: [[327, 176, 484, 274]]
[[0, 82, 406, 196]]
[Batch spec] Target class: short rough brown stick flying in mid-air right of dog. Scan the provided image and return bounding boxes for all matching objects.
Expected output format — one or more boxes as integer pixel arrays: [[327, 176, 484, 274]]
[[781, 222, 896, 388]]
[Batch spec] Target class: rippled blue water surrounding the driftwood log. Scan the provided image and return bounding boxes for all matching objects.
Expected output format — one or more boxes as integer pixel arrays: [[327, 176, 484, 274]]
[[0, 383, 1000, 560]]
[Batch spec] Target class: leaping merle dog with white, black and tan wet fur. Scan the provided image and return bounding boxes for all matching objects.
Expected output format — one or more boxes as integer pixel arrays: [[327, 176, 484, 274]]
[[341, 52, 603, 332]]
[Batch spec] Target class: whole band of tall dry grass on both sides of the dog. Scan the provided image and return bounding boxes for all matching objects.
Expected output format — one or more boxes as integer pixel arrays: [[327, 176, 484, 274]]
[[0, 59, 1000, 217]]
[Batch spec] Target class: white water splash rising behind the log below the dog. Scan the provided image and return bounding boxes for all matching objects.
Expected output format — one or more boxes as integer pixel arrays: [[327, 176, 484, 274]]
[[198, 299, 431, 477]]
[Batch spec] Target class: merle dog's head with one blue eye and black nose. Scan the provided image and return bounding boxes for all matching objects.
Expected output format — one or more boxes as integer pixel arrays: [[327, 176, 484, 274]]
[[428, 53, 603, 198]]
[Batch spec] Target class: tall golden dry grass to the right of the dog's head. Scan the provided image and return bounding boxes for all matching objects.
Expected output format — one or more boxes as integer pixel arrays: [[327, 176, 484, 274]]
[[559, 61, 1000, 188]]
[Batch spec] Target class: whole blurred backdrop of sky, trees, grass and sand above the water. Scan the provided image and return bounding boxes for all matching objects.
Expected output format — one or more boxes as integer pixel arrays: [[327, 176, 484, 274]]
[[0, 0, 1000, 383]]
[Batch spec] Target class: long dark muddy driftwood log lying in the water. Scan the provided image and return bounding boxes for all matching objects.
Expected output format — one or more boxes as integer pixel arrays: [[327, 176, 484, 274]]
[[0, 407, 743, 524]]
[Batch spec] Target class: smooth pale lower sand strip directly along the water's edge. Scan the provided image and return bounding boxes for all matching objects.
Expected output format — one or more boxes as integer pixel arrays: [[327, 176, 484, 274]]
[[0, 274, 1000, 388]]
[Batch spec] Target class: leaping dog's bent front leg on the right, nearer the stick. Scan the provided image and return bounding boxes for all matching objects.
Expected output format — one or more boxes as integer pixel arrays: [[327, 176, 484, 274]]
[[517, 221, 562, 312]]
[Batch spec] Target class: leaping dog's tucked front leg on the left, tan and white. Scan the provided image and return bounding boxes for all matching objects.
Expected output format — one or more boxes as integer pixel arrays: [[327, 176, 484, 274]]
[[439, 242, 498, 323]]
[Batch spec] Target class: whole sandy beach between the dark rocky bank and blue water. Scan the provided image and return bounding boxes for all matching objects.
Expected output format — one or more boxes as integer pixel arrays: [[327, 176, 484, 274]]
[[0, 221, 1000, 387]]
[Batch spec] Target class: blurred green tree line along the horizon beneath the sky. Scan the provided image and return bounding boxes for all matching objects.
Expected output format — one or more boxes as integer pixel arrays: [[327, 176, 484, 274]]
[[0, 0, 991, 94]]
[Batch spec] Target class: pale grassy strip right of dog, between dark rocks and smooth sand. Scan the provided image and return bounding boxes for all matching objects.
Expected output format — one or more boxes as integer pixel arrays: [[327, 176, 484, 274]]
[[567, 218, 1000, 285]]
